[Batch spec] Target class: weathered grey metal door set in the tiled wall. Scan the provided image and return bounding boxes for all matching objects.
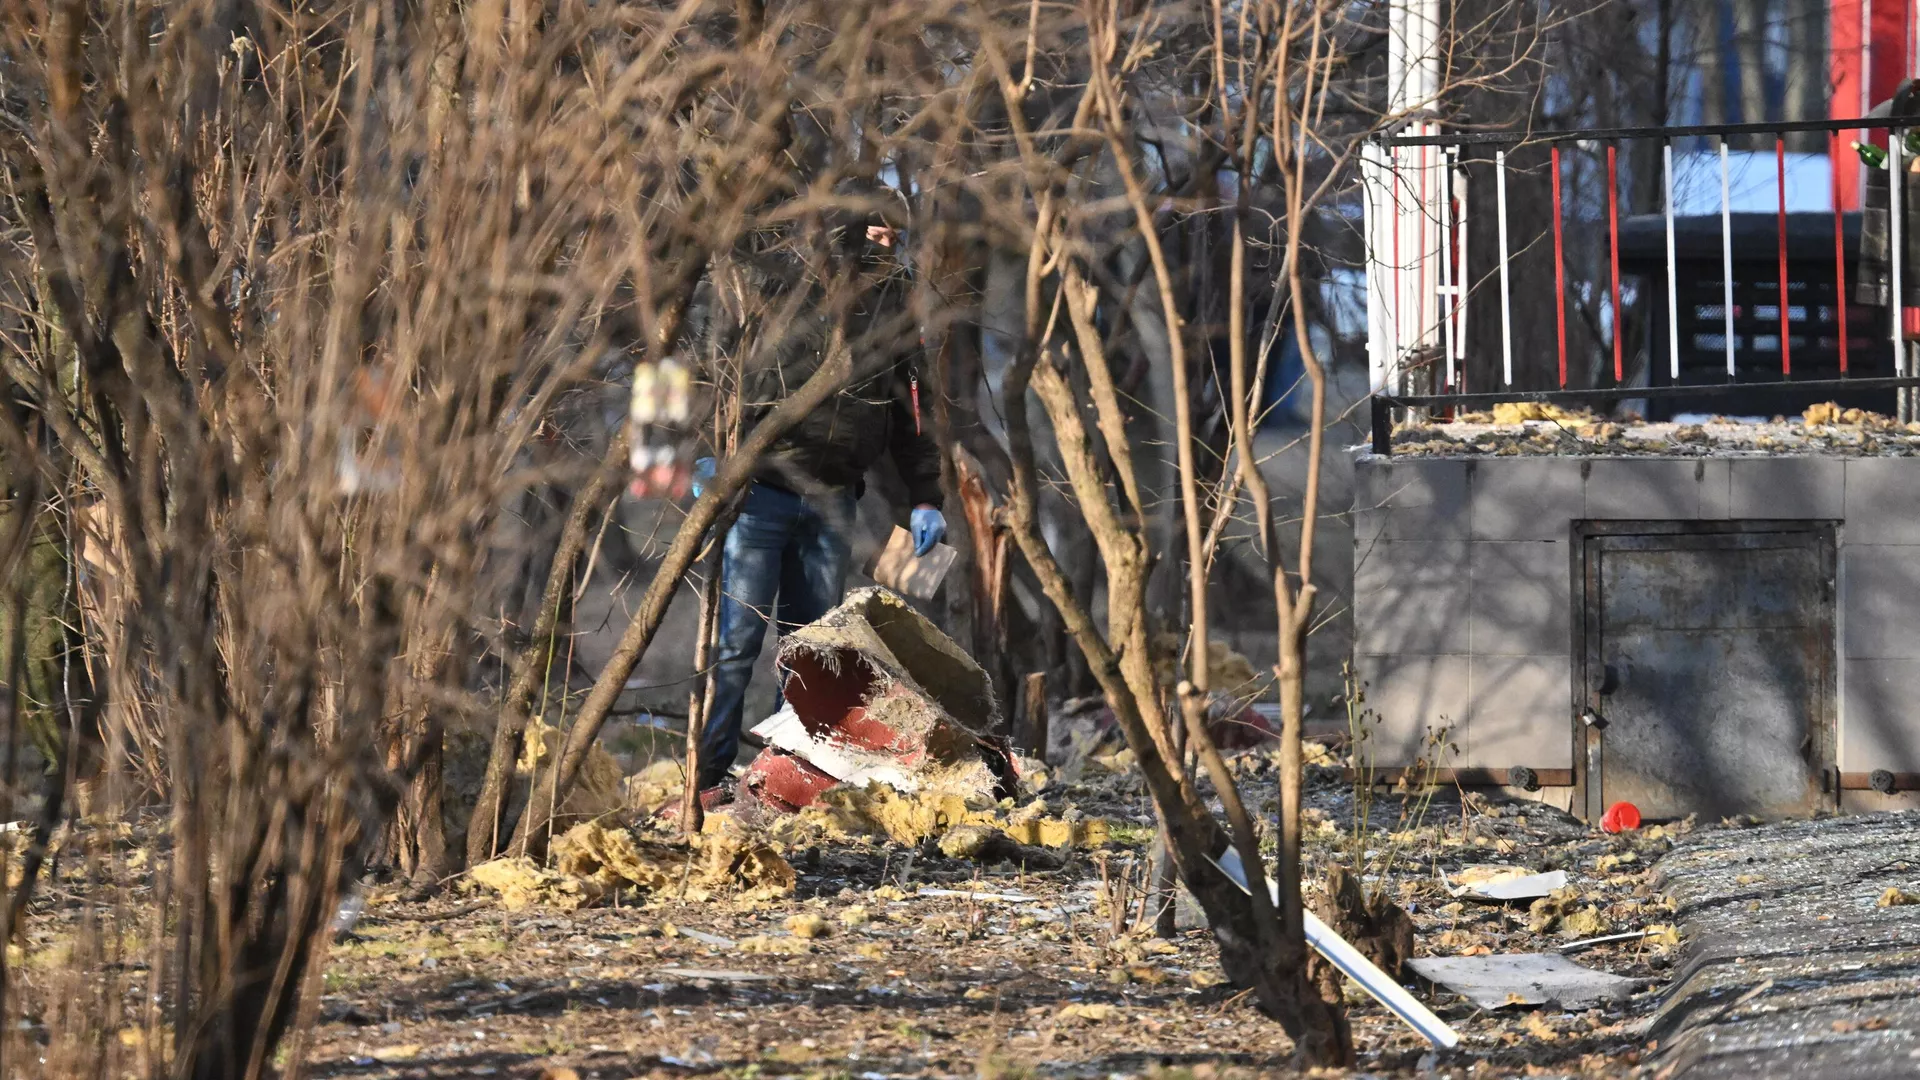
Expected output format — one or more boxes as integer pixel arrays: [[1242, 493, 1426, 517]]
[[1574, 521, 1834, 821]]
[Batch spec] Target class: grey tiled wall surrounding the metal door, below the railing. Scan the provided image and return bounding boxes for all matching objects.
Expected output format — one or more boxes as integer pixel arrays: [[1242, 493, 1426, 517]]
[[1354, 457, 1920, 773]]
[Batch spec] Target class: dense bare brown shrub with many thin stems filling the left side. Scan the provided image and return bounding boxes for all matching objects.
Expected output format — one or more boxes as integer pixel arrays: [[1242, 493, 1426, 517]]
[[0, 0, 939, 1078]]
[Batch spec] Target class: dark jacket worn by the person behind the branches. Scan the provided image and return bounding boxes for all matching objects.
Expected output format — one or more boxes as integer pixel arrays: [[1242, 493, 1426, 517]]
[[689, 253, 941, 505]]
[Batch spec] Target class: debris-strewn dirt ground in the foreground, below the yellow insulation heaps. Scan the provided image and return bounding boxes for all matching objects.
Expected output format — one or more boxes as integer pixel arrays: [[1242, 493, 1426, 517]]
[[251, 751, 1672, 1080]]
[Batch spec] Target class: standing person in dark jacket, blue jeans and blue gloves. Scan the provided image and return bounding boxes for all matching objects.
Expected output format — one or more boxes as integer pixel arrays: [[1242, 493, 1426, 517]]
[[693, 223, 947, 803]]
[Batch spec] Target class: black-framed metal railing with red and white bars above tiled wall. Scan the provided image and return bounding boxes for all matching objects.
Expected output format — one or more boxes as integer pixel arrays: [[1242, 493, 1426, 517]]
[[1361, 115, 1920, 452]]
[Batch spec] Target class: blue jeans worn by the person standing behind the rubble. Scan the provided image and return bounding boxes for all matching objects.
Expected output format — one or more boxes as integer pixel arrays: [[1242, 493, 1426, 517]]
[[699, 482, 854, 788]]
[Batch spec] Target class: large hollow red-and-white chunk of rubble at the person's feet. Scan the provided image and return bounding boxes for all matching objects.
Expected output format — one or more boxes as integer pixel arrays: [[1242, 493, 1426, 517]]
[[741, 588, 1014, 813]]
